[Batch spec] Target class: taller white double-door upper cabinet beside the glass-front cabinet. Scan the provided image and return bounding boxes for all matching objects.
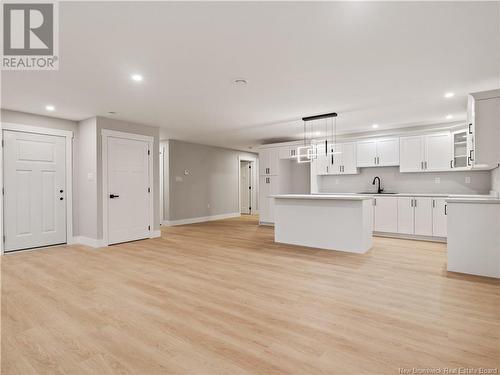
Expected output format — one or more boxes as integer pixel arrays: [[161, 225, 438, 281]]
[[400, 132, 453, 172]]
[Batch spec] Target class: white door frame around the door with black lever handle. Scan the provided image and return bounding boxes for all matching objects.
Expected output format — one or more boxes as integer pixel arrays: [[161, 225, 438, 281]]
[[101, 129, 155, 246]]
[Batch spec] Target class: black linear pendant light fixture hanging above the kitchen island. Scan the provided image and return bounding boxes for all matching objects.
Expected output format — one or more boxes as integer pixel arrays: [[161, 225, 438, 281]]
[[297, 112, 338, 163]]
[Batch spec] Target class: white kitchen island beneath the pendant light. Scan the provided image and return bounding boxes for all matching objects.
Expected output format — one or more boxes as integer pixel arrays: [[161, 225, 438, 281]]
[[272, 194, 373, 253]]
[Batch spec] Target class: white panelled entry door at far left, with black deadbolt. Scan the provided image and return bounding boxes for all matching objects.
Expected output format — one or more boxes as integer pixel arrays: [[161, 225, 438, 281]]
[[3, 131, 66, 251]]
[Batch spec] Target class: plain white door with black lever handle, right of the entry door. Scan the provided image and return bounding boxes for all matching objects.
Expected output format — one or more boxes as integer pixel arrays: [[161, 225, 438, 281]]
[[105, 137, 152, 244]]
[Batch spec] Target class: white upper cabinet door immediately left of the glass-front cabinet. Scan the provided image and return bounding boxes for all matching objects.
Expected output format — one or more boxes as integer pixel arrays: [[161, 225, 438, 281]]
[[424, 132, 452, 171]]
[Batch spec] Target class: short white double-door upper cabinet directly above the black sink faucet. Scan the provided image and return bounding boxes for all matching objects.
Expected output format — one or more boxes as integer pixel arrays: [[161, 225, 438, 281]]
[[356, 137, 399, 167]]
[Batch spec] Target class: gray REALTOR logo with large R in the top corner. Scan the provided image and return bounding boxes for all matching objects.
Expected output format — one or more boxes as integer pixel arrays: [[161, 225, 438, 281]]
[[2, 3, 58, 70]]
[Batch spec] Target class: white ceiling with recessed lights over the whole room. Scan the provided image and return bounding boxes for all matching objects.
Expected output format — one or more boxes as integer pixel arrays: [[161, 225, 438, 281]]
[[1, 2, 500, 148]]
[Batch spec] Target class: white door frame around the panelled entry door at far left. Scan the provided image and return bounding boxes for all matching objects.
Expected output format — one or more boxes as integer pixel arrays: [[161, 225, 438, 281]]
[[0, 122, 75, 254]]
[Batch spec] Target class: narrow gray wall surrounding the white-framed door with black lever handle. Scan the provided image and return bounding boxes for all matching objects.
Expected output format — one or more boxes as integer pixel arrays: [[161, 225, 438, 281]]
[[97, 117, 160, 238]]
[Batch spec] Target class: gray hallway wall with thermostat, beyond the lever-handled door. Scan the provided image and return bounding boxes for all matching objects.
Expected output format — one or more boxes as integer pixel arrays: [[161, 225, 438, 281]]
[[164, 140, 258, 221]]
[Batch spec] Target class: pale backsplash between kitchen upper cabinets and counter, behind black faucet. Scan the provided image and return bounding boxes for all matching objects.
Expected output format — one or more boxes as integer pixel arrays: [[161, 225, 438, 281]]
[[318, 167, 492, 194]]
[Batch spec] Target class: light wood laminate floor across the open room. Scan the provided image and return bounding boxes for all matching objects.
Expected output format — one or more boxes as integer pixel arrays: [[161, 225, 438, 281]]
[[1, 216, 500, 375]]
